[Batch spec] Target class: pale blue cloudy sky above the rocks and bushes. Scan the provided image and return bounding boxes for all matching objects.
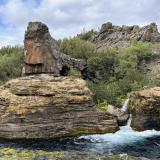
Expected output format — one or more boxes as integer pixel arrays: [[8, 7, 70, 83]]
[[0, 0, 160, 47]]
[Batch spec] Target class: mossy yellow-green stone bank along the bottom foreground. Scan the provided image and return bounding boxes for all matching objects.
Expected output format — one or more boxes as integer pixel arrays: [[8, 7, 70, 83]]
[[0, 148, 157, 160]]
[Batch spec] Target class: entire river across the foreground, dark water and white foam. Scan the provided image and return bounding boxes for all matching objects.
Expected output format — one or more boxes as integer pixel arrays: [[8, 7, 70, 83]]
[[0, 99, 160, 158]]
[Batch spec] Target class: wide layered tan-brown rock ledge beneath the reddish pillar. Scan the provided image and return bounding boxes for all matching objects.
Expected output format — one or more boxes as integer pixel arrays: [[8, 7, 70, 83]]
[[0, 75, 118, 139]]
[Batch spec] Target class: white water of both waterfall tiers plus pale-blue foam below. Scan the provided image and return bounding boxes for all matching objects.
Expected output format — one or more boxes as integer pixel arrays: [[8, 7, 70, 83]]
[[78, 99, 160, 153]]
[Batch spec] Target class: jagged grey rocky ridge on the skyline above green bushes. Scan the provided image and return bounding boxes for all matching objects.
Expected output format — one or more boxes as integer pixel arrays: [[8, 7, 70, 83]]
[[92, 22, 160, 48]]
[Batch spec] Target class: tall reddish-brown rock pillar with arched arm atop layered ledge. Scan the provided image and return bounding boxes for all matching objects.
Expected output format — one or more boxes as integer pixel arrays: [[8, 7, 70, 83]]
[[23, 22, 87, 78]]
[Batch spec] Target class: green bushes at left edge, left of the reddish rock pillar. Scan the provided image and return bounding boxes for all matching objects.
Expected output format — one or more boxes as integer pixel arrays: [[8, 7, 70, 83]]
[[0, 46, 23, 82]]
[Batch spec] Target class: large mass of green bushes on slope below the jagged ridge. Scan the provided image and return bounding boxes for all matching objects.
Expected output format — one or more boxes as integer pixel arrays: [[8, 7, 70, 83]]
[[61, 38, 159, 108]]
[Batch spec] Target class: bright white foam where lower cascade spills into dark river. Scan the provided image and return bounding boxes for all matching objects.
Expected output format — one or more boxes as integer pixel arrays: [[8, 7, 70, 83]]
[[79, 115, 160, 146]]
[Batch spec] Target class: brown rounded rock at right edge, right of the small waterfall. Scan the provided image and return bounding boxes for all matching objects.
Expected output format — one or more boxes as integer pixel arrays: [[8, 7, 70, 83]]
[[129, 87, 160, 131]]
